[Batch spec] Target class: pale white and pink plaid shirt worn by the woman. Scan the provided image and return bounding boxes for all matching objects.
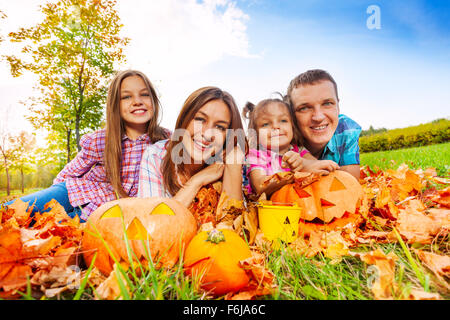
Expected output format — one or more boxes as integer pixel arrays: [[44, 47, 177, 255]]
[[137, 140, 172, 198]]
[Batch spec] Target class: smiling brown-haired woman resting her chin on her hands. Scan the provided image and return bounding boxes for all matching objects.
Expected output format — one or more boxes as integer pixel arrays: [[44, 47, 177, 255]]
[[138, 87, 246, 207]]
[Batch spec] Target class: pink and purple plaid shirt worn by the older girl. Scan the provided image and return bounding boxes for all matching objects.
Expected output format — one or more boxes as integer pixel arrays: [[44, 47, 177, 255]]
[[53, 129, 151, 220]]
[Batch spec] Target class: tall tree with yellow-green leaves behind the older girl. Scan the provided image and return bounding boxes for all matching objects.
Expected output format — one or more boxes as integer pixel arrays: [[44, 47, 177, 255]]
[[4, 0, 129, 162]]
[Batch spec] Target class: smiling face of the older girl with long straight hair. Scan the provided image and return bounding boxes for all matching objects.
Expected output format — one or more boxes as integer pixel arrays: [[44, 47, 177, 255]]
[[120, 76, 153, 139]]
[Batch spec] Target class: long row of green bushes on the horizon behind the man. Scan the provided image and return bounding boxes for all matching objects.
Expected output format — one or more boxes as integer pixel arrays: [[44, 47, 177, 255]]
[[359, 119, 450, 153]]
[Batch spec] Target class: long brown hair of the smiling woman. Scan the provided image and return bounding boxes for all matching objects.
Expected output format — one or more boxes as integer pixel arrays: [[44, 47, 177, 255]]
[[161, 87, 245, 196]]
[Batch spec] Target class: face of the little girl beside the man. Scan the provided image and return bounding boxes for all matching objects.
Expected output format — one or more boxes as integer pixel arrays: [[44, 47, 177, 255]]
[[256, 103, 294, 154]]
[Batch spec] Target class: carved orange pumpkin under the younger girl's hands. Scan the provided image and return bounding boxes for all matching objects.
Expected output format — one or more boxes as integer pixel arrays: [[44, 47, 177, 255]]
[[271, 170, 363, 225]]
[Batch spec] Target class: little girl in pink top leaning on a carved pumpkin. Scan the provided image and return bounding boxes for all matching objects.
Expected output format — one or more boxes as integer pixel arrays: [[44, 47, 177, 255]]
[[243, 99, 339, 197]]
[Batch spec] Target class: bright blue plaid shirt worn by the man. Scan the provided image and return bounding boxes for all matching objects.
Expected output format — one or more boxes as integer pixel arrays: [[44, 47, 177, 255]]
[[319, 114, 361, 166]]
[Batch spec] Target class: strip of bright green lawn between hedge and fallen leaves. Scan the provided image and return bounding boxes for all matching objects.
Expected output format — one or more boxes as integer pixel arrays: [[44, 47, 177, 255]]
[[360, 142, 450, 176]]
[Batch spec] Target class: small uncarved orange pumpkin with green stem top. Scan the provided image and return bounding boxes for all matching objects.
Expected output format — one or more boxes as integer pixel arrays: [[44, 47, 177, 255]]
[[184, 229, 252, 296]]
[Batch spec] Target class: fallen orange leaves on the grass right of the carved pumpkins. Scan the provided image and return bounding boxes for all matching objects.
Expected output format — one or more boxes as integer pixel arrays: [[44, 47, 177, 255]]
[[282, 164, 450, 299]]
